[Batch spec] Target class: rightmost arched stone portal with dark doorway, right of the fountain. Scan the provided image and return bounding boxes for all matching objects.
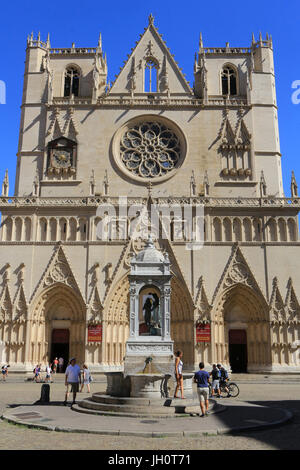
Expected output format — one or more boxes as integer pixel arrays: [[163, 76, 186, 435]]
[[212, 284, 271, 372]]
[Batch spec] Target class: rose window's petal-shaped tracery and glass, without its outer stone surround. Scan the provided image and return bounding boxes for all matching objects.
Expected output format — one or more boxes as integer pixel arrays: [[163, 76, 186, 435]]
[[120, 122, 181, 178]]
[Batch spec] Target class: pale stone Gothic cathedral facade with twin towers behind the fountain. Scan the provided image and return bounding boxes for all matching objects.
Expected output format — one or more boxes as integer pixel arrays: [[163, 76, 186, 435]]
[[0, 16, 300, 373]]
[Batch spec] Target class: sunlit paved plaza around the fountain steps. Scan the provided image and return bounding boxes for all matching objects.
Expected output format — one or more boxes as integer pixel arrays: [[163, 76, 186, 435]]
[[0, 374, 300, 450]]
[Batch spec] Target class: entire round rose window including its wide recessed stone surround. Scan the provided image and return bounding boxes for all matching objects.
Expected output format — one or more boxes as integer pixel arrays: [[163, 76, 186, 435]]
[[112, 115, 187, 184]]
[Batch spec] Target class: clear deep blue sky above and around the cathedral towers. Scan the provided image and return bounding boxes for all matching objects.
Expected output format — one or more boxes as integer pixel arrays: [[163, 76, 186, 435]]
[[0, 0, 300, 197]]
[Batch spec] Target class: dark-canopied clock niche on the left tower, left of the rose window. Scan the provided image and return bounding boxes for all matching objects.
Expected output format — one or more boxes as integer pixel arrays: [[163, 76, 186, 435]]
[[46, 137, 77, 179]]
